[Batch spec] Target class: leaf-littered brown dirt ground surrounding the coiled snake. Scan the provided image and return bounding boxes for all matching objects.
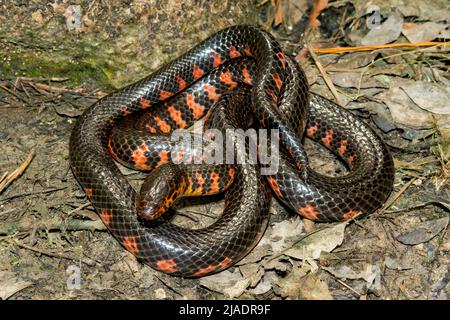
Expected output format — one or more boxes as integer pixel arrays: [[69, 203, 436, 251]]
[[0, 0, 450, 300]]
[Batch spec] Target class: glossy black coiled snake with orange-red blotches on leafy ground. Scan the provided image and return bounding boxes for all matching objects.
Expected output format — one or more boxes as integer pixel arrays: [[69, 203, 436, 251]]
[[69, 25, 394, 277]]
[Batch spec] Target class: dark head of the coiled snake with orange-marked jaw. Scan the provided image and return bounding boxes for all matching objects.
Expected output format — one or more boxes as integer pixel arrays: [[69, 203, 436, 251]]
[[136, 164, 185, 220]]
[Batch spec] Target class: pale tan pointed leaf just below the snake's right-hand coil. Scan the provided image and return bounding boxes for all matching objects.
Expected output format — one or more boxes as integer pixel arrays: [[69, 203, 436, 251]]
[[284, 221, 348, 260]]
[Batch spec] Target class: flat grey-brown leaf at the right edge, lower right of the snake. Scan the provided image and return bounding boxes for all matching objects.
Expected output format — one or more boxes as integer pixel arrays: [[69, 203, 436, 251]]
[[397, 217, 449, 245]]
